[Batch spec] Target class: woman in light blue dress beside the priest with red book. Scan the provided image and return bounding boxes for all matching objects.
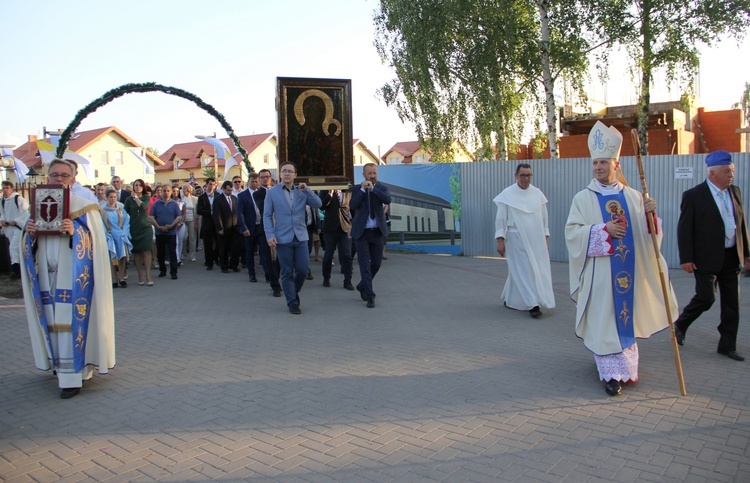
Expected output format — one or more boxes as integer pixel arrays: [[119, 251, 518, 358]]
[[101, 186, 133, 288]]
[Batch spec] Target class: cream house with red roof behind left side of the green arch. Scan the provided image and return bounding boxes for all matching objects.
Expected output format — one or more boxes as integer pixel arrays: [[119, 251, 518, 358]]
[[13, 126, 163, 185]]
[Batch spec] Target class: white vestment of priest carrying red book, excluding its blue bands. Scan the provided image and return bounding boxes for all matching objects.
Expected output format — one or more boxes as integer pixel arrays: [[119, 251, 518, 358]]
[[21, 193, 115, 388]]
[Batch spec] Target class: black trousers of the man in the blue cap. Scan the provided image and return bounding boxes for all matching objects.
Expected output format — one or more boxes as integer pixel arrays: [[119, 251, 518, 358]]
[[675, 247, 740, 351]]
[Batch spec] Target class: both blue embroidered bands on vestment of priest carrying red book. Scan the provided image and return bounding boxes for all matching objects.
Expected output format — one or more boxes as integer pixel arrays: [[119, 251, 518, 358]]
[[23, 214, 94, 372]]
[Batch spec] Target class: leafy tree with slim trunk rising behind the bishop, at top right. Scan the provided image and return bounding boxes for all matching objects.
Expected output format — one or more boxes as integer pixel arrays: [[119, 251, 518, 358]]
[[592, 0, 750, 155]]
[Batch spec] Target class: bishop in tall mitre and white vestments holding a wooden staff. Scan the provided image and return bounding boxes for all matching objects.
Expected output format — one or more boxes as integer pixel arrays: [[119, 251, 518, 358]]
[[565, 122, 679, 396]]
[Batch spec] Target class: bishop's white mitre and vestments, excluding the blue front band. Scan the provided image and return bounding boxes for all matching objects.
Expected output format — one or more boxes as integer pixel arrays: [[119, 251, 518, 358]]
[[565, 122, 679, 382]]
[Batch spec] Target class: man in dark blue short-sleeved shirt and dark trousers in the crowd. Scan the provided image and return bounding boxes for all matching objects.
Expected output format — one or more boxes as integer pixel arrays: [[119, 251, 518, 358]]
[[149, 185, 182, 280]]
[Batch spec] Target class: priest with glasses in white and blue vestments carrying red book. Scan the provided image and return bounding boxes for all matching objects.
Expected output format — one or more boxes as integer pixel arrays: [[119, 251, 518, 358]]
[[21, 159, 115, 399]]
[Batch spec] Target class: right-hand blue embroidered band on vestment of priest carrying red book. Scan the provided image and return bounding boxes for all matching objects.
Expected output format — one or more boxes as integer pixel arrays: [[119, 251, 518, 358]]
[[71, 214, 94, 372]]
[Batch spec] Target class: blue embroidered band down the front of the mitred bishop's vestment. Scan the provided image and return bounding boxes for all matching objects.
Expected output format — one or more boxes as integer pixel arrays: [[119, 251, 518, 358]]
[[596, 190, 635, 349]]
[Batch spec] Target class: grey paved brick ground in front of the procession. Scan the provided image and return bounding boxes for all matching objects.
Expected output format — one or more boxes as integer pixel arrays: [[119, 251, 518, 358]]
[[0, 254, 750, 482]]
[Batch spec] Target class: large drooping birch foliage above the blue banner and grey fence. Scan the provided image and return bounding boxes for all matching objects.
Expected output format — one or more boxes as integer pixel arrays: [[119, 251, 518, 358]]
[[375, 0, 589, 160]]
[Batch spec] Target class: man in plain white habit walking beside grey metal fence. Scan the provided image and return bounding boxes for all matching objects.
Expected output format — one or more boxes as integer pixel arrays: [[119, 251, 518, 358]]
[[492, 163, 555, 318]]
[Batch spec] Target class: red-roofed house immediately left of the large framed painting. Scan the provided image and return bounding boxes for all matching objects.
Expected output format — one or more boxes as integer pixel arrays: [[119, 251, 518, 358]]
[[156, 133, 277, 183]]
